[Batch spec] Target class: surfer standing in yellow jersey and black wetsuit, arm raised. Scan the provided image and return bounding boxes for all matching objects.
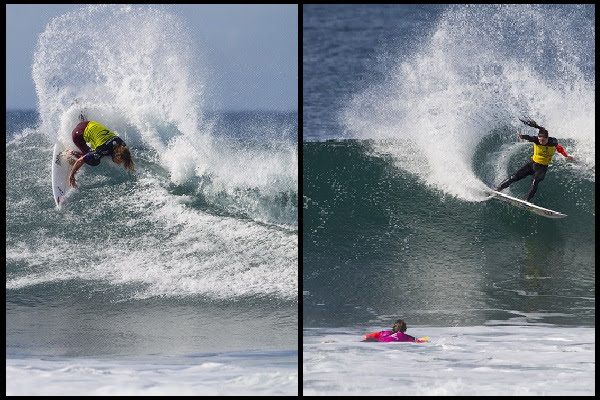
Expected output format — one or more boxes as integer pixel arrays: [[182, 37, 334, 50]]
[[496, 118, 575, 201]]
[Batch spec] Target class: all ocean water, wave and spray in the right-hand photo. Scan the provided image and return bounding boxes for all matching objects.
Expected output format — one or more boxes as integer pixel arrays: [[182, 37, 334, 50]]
[[302, 5, 595, 395]]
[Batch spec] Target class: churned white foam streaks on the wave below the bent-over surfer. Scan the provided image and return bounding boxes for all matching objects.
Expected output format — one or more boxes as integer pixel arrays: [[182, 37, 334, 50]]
[[6, 171, 298, 300]]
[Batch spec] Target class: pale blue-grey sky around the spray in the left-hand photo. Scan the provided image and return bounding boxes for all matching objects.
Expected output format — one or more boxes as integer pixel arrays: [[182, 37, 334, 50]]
[[6, 4, 298, 110]]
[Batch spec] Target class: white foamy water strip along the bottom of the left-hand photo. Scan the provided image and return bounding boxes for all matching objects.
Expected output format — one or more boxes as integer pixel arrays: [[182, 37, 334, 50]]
[[6, 352, 298, 396]]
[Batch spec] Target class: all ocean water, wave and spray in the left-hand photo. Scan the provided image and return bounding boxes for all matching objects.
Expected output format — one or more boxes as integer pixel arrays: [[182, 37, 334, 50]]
[[6, 6, 299, 396]]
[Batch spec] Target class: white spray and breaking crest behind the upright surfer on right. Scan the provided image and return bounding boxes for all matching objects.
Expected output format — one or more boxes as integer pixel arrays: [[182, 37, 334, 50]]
[[339, 5, 595, 200]]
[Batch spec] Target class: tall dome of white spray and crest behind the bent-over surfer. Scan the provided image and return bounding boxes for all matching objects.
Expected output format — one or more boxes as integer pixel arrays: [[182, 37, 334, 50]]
[[33, 5, 298, 226]]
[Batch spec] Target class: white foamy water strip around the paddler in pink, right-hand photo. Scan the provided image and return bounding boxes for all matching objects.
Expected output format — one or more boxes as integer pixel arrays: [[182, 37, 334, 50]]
[[302, 321, 595, 396]]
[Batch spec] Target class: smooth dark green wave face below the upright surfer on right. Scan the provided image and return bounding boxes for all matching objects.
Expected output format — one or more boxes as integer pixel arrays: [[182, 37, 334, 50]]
[[302, 141, 595, 327]]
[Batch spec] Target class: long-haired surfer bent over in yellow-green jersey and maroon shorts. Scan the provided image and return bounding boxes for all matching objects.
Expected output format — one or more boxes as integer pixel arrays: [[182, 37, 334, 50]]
[[67, 114, 134, 187]]
